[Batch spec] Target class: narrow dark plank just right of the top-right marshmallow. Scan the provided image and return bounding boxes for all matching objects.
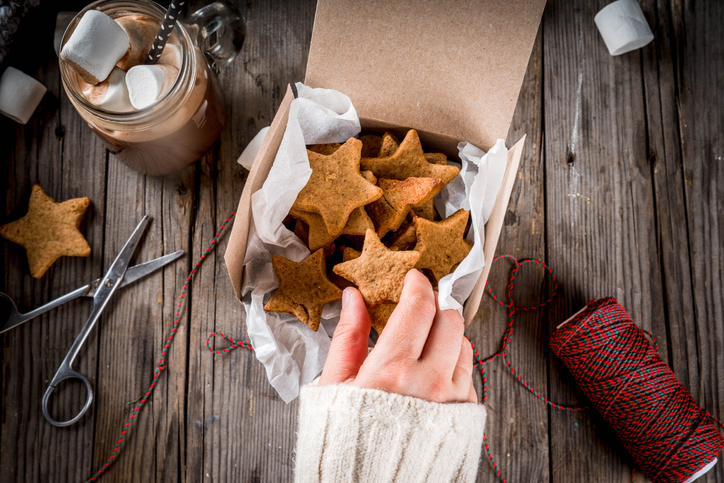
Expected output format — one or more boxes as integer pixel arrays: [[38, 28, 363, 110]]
[[641, 0, 699, 398]]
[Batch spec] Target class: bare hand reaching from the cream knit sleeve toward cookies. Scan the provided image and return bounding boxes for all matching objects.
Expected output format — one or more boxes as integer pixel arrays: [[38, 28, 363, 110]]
[[319, 270, 478, 403]]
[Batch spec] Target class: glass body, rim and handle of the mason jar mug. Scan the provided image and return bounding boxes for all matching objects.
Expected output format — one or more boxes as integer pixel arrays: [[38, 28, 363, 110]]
[[60, 0, 244, 175]]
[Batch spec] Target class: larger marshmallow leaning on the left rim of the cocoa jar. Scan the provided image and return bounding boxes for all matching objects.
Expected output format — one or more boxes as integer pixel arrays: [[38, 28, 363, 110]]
[[60, 10, 129, 84]]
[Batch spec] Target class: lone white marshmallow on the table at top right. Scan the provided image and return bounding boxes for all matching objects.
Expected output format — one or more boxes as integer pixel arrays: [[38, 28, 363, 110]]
[[593, 0, 654, 55]]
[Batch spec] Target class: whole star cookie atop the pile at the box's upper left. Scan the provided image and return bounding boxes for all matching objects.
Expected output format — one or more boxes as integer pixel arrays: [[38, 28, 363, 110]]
[[293, 138, 382, 237]]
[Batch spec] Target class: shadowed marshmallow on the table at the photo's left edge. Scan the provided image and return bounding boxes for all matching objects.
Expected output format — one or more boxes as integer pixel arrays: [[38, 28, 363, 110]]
[[0, 67, 47, 124]]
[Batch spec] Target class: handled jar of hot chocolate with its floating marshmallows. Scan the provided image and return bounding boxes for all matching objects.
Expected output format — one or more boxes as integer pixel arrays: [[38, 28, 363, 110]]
[[60, 0, 244, 175]]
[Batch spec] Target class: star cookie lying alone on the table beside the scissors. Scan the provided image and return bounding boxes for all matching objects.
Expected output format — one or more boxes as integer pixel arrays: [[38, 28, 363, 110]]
[[0, 184, 91, 278]]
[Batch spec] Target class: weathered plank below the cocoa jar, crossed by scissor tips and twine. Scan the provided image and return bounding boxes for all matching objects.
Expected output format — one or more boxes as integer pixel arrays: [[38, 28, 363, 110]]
[[88, 161, 195, 481]]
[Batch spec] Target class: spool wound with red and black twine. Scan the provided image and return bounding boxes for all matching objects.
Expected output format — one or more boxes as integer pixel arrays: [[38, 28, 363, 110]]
[[550, 298, 724, 483]]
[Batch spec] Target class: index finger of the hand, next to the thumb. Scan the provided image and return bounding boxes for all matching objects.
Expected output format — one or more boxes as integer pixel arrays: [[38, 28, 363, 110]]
[[375, 269, 437, 359]]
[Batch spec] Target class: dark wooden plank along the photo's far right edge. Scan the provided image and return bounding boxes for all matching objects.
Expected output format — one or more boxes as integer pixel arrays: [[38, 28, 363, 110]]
[[670, 1, 724, 482]]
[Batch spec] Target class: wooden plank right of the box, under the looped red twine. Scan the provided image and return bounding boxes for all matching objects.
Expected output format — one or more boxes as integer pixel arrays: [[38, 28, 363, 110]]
[[468, 28, 549, 481]]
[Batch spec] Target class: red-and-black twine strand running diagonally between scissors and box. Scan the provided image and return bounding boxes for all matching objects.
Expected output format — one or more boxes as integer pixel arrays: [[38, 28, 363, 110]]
[[86, 211, 236, 483]]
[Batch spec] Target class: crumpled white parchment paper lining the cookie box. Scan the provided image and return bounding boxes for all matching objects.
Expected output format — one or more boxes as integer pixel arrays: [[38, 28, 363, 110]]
[[242, 83, 508, 402]]
